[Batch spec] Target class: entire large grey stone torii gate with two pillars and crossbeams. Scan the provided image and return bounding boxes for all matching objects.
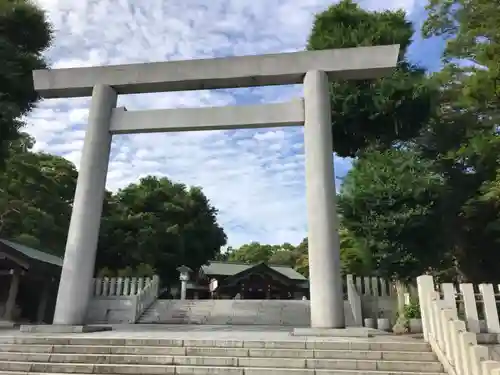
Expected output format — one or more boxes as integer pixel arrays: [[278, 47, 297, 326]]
[[33, 45, 399, 328]]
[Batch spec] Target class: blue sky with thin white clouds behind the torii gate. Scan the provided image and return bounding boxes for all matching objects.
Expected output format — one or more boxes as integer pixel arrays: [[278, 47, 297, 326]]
[[27, 0, 443, 250]]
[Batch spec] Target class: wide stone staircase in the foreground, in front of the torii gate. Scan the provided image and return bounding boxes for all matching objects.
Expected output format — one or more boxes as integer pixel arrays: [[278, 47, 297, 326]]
[[0, 336, 443, 375]]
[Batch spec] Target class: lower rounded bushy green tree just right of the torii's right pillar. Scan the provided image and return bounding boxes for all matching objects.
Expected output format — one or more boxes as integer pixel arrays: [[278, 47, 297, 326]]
[[339, 149, 446, 279]]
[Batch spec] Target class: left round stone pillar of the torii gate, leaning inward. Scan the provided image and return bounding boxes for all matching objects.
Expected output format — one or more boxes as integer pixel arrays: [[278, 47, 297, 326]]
[[54, 85, 117, 325]]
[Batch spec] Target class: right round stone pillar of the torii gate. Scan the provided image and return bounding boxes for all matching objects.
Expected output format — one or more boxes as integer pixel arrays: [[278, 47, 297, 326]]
[[304, 70, 345, 328]]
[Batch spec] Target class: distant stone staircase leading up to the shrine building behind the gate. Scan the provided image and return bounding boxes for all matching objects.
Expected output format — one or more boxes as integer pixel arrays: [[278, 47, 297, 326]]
[[138, 300, 355, 327]]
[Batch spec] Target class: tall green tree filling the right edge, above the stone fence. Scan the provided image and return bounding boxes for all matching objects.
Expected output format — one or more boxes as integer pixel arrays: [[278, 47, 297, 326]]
[[419, 0, 500, 282]]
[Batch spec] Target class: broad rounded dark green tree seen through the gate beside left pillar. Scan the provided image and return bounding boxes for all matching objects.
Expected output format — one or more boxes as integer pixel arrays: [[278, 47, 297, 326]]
[[96, 176, 226, 282]]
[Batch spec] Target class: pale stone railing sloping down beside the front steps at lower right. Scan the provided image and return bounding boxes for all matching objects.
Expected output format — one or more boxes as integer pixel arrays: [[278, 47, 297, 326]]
[[417, 275, 500, 375]]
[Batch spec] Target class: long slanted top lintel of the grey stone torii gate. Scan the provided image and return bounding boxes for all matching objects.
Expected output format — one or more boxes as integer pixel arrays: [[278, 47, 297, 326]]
[[33, 45, 399, 98]]
